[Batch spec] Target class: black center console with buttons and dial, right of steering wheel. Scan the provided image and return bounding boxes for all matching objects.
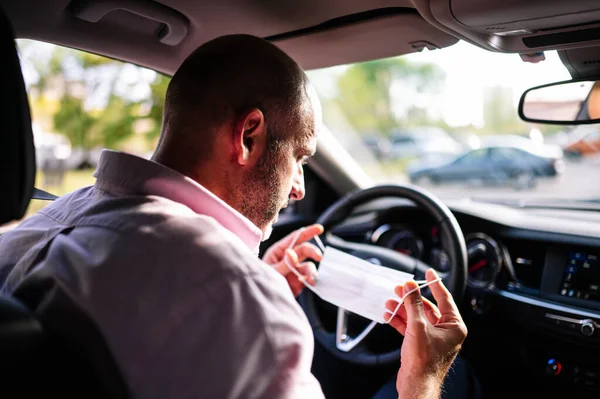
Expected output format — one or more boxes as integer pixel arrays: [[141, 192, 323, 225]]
[[496, 241, 600, 394]]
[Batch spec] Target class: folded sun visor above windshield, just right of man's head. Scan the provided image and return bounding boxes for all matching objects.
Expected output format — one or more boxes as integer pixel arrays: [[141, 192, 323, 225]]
[[269, 13, 458, 69]]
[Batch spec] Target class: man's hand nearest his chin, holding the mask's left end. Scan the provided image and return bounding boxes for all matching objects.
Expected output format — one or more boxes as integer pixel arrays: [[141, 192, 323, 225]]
[[263, 224, 323, 296]]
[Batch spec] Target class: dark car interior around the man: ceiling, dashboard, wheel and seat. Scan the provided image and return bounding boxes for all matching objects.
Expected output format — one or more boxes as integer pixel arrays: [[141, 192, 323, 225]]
[[0, 0, 600, 398]]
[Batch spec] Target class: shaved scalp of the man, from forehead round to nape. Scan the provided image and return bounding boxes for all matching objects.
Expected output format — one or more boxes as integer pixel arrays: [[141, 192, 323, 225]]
[[159, 35, 314, 166]]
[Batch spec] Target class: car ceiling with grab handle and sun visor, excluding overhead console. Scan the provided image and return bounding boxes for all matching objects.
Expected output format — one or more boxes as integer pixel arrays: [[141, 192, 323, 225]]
[[0, 0, 457, 74]]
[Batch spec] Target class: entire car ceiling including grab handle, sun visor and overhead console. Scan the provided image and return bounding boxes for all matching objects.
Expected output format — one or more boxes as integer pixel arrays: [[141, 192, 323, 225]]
[[0, 0, 600, 77]]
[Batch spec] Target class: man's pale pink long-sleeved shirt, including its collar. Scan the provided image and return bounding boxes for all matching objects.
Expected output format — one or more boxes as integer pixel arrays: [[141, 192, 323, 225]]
[[0, 150, 323, 399]]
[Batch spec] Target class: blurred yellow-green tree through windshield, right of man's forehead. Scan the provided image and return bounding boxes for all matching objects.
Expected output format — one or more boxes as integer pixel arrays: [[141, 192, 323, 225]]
[[334, 58, 445, 133]]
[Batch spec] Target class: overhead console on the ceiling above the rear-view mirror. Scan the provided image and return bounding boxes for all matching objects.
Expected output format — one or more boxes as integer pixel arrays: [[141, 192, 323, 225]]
[[412, 0, 600, 54]]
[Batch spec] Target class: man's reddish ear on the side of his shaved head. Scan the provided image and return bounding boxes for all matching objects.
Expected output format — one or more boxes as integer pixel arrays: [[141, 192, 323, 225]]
[[233, 108, 267, 166]]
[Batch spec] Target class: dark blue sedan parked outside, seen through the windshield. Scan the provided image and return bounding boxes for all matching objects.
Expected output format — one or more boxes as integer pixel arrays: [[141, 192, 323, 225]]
[[409, 145, 564, 189]]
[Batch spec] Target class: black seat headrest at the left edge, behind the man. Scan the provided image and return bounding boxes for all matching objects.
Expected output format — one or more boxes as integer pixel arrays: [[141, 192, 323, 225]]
[[0, 9, 36, 224]]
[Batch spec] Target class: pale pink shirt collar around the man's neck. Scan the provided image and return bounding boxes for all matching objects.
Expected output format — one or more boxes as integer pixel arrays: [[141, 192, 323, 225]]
[[94, 150, 262, 254]]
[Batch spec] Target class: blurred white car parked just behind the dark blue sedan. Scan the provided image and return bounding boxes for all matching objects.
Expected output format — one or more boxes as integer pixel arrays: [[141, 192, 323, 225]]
[[390, 126, 463, 159]]
